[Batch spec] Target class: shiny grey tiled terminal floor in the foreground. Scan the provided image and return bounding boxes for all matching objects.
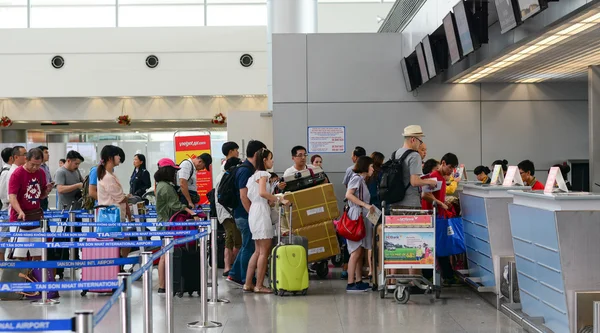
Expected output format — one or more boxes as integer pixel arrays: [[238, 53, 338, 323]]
[[0, 271, 524, 333]]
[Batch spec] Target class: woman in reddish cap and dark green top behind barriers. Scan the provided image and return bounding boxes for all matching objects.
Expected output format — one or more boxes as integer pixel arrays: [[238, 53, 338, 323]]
[[154, 158, 198, 294]]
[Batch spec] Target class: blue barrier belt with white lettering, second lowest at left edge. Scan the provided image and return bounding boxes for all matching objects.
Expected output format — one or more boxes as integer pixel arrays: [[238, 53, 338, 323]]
[[0, 280, 119, 292]]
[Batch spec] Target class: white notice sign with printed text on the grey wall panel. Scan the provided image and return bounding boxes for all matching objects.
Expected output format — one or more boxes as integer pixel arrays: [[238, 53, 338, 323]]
[[308, 126, 346, 154]]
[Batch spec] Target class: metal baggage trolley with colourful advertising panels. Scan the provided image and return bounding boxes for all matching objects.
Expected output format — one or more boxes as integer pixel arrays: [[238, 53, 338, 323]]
[[377, 203, 441, 304]]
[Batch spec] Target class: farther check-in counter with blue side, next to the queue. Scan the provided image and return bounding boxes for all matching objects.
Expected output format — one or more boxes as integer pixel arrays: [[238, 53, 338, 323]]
[[460, 184, 530, 295]]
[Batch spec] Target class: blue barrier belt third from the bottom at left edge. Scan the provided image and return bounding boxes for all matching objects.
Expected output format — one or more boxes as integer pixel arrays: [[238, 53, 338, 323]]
[[0, 257, 140, 269]]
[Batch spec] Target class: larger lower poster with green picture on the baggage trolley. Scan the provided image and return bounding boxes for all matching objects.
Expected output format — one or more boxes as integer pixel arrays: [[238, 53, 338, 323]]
[[383, 231, 435, 265]]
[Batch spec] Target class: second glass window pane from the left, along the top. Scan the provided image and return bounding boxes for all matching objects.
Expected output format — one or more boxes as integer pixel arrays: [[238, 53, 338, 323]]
[[31, 6, 116, 28]]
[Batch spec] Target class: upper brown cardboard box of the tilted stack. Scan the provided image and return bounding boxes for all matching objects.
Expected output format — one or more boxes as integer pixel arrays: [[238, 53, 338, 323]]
[[285, 184, 340, 229]]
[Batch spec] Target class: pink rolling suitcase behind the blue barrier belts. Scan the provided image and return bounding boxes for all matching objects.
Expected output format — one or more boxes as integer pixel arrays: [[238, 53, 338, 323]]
[[81, 238, 120, 296]]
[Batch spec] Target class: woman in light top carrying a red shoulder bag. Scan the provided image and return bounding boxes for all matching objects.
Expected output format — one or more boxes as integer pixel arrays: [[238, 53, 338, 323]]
[[346, 156, 375, 292]]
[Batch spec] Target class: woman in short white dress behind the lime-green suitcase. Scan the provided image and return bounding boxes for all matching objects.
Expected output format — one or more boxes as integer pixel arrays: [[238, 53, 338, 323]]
[[243, 148, 290, 294]]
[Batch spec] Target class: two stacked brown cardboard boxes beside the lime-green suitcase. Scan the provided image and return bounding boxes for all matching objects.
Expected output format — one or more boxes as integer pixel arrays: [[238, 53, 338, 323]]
[[282, 184, 340, 262]]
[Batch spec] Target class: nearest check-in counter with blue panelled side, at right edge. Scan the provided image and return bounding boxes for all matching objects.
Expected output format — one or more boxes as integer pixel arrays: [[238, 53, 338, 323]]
[[509, 191, 600, 333]]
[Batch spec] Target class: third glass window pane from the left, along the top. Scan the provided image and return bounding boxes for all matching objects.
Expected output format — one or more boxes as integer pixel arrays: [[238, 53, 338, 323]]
[[119, 5, 204, 27]]
